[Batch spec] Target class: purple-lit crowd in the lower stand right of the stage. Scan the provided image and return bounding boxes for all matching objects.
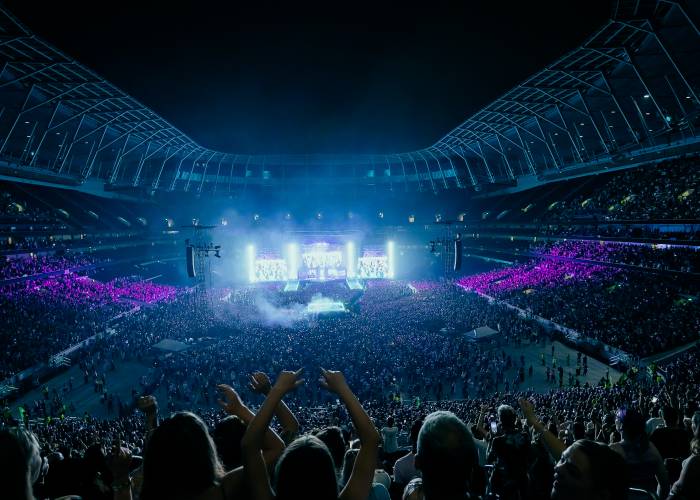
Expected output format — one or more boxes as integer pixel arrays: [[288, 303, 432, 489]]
[[458, 241, 700, 356]]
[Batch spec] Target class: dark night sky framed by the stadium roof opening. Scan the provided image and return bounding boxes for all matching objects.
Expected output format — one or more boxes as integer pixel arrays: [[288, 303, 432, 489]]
[[4, 0, 611, 154]]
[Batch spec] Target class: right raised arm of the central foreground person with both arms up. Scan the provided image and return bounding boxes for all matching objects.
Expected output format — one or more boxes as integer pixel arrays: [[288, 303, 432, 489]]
[[319, 368, 380, 500]]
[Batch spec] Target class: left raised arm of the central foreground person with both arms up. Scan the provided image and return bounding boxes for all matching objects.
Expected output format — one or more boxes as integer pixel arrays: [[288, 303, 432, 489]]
[[241, 370, 304, 500]]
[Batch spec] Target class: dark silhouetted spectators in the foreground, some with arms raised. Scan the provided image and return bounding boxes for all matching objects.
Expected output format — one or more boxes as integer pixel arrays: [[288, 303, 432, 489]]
[[0, 360, 700, 499]]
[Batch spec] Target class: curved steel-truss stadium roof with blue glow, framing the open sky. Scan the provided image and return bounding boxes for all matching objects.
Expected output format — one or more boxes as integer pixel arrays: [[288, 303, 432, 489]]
[[0, 0, 700, 193]]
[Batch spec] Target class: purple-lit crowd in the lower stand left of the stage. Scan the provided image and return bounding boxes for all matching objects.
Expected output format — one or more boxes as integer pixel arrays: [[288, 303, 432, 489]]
[[0, 256, 177, 380]]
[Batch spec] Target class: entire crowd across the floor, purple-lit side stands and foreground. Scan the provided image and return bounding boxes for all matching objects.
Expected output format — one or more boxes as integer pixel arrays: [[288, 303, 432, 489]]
[[0, 235, 700, 500]]
